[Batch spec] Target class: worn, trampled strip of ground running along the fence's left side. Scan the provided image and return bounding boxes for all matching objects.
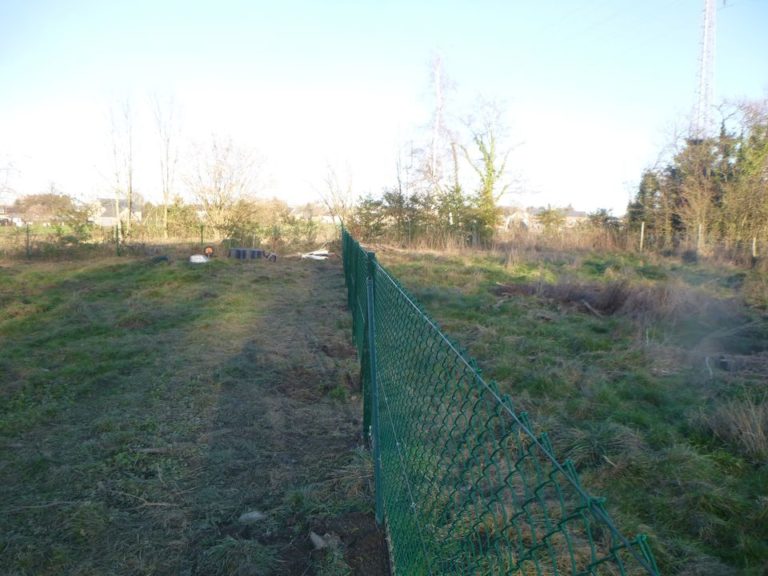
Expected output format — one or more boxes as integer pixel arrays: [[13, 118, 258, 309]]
[[187, 262, 385, 575]]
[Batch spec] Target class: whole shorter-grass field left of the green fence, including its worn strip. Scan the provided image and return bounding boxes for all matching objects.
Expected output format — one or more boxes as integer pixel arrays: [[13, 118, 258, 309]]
[[0, 252, 385, 576]]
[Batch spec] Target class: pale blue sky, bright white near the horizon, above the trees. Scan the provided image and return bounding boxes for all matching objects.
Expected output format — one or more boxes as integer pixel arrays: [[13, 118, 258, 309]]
[[0, 0, 768, 213]]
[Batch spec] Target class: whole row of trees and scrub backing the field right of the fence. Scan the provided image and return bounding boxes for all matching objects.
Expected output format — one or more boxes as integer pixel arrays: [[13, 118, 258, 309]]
[[345, 100, 768, 264]]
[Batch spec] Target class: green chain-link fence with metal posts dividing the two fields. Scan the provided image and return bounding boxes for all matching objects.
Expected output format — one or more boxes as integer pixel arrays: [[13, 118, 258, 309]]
[[342, 231, 658, 576]]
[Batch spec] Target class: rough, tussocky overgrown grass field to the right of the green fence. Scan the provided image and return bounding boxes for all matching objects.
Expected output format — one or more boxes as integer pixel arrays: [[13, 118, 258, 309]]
[[378, 249, 768, 575]]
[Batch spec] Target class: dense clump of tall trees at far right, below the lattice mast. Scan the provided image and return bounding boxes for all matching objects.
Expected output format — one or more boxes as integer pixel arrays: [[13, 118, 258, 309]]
[[627, 100, 768, 258]]
